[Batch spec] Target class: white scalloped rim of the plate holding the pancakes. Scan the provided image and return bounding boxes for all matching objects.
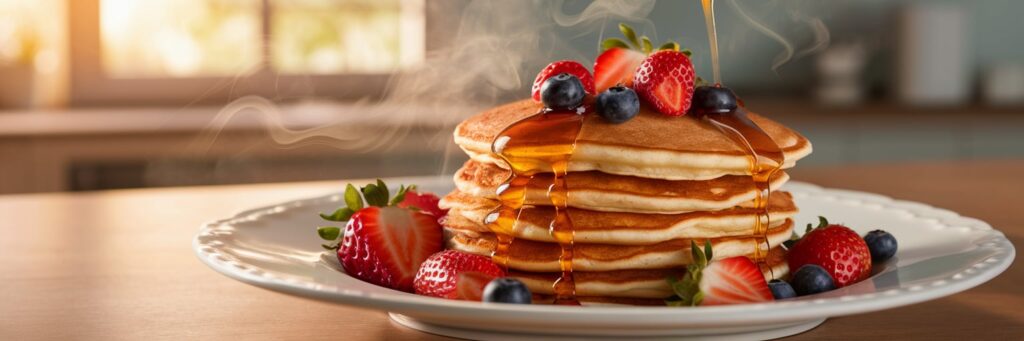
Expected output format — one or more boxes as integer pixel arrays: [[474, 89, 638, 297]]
[[193, 177, 1016, 329]]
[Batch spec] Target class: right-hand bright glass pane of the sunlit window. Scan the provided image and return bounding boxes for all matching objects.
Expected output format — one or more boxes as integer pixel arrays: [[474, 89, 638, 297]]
[[270, 0, 424, 74]]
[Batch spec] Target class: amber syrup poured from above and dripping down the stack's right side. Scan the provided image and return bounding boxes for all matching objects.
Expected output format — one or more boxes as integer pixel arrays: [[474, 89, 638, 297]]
[[697, 0, 785, 278]]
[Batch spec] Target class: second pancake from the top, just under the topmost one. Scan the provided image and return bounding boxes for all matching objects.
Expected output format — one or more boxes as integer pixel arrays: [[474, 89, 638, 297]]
[[455, 160, 790, 214]]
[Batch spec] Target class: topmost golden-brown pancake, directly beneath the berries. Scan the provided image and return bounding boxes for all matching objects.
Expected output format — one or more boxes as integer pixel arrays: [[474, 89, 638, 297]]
[[455, 99, 811, 180]]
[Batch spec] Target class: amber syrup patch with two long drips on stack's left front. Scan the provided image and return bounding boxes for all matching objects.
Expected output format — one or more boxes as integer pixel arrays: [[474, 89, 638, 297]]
[[484, 105, 590, 304]]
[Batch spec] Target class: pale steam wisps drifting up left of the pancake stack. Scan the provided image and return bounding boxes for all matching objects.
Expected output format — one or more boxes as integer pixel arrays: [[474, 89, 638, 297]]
[[182, 0, 654, 182]]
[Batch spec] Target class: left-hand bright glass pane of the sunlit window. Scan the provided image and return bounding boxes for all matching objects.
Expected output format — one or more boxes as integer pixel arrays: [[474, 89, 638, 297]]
[[100, 0, 261, 77]]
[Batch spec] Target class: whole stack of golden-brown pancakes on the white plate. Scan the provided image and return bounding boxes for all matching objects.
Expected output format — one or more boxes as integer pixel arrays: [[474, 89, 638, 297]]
[[441, 99, 811, 304]]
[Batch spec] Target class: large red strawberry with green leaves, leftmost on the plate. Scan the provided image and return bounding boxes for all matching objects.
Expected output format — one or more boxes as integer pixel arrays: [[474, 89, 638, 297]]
[[317, 179, 442, 292]]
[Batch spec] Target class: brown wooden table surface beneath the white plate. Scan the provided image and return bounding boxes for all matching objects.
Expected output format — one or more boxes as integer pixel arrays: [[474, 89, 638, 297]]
[[0, 161, 1024, 340]]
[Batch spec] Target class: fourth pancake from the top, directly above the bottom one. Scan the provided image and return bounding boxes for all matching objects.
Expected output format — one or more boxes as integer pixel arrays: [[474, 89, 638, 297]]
[[444, 220, 793, 272]]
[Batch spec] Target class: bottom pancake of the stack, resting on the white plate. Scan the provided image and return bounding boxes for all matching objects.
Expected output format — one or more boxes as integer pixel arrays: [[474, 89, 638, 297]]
[[509, 248, 790, 304]]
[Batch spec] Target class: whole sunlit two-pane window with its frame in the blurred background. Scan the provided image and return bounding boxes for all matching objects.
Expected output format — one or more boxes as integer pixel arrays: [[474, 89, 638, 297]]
[[68, 0, 426, 105]]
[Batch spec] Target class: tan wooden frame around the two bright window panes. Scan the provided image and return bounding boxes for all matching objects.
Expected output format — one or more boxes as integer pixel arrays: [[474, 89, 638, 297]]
[[67, 0, 425, 106]]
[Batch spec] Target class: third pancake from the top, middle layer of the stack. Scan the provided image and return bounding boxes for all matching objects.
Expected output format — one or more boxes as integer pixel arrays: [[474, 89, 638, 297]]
[[441, 189, 797, 245]]
